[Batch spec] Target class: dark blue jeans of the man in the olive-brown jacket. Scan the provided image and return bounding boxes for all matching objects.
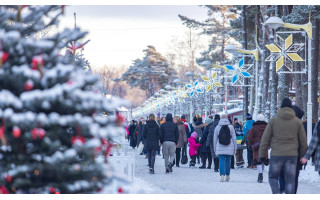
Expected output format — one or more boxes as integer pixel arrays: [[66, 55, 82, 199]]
[[269, 156, 297, 194]]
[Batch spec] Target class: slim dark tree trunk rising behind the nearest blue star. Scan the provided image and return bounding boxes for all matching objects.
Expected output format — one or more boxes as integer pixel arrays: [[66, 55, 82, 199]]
[[241, 5, 248, 120]]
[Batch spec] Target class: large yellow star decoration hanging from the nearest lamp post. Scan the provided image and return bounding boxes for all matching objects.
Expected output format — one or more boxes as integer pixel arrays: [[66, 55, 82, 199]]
[[266, 34, 305, 72]]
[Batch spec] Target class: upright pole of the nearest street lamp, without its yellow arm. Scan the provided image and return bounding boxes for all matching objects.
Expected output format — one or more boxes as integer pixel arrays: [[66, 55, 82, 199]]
[[307, 37, 312, 144]]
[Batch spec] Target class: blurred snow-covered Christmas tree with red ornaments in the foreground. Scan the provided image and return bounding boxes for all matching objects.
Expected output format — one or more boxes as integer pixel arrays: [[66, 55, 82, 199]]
[[0, 6, 123, 193]]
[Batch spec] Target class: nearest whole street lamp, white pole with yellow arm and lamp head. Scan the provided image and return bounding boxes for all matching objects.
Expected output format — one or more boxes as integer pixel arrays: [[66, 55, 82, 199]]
[[265, 15, 312, 143]]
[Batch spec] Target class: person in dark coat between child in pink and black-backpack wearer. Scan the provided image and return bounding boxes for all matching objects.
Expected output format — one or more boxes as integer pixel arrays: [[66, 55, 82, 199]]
[[199, 118, 213, 169]]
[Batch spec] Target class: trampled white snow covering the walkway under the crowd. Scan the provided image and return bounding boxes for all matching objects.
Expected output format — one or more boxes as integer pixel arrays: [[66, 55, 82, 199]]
[[131, 145, 320, 194]]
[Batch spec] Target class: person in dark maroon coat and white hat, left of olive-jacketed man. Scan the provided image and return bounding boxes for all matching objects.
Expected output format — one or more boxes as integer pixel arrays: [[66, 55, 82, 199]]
[[247, 114, 268, 183]]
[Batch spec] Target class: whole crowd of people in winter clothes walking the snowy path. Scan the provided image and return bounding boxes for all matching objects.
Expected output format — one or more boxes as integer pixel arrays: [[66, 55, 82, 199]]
[[127, 98, 320, 194]]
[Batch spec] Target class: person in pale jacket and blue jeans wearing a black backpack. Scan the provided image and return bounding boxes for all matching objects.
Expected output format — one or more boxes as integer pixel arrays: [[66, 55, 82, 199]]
[[213, 114, 237, 182]]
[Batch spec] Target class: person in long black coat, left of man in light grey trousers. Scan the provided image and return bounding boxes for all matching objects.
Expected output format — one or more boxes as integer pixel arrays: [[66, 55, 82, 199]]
[[142, 114, 160, 174]]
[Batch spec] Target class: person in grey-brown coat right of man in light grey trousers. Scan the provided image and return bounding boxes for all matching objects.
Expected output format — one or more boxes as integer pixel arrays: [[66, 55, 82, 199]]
[[173, 116, 187, 167]]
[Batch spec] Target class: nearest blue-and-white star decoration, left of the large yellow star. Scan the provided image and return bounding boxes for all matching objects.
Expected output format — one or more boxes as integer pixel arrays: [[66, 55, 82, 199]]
[[226, 58, 253, 86]]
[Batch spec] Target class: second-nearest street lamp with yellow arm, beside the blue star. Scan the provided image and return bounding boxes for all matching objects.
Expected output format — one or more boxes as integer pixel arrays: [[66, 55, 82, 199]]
[[225, 45, 259, 119]]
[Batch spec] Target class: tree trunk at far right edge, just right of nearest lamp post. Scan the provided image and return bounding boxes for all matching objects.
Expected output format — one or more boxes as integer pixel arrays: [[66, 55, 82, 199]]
[[311, 19, 319, 121]]
